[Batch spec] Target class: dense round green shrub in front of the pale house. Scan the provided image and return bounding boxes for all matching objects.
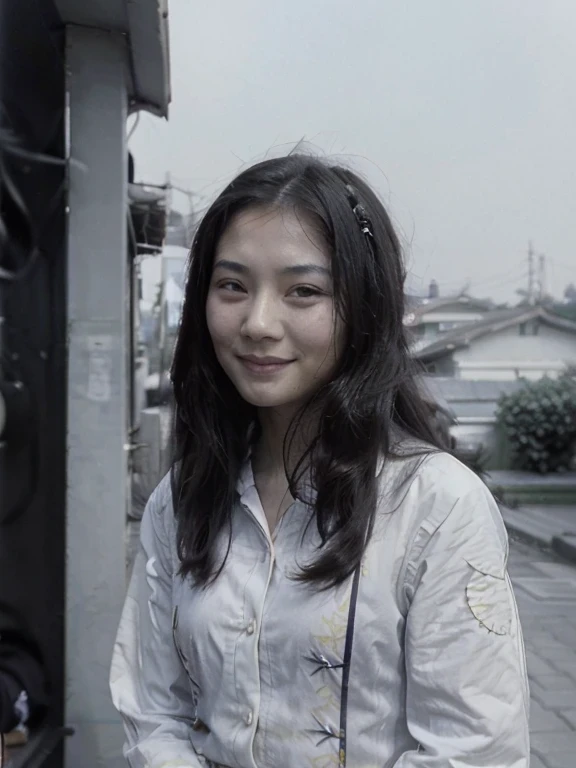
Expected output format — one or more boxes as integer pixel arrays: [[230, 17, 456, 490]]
[[497, 375, 576, 474]]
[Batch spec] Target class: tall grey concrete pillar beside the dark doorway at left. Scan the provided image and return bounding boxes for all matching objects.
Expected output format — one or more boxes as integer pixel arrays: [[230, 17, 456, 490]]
[[66, 26, 129, 768]]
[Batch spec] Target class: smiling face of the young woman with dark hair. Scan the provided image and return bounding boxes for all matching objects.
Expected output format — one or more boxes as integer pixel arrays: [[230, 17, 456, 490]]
[[206, 208, 342, 410]]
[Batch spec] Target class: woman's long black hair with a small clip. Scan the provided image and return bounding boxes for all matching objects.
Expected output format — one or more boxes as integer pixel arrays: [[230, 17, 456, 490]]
[[171, 154, 441, 588]]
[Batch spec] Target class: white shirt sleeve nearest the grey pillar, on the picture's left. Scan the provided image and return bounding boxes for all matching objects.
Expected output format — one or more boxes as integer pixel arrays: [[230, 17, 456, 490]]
[[110, 478, 206, 768]]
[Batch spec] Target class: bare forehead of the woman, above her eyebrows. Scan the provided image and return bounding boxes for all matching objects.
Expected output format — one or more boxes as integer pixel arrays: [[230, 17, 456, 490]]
[[216, 207, 330, 266]]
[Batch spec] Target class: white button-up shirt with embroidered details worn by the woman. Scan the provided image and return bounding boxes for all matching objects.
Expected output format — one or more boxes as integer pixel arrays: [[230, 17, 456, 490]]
[[111, 453, 530, 768]]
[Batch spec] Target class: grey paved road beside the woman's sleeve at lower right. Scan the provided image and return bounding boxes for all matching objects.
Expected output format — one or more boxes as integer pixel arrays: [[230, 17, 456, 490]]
[[509, 541, 576, 768]]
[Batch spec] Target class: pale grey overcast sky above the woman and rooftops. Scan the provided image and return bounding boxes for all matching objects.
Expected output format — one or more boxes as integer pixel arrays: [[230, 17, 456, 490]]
[[130, 0, 576, 300]]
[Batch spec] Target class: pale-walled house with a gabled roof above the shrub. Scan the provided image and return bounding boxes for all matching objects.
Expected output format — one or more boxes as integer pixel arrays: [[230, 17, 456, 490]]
[[414, 306, 576, 381]]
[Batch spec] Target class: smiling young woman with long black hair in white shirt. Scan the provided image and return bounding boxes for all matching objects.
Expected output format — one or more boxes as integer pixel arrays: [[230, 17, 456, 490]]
[[111, 155, 529, 768]]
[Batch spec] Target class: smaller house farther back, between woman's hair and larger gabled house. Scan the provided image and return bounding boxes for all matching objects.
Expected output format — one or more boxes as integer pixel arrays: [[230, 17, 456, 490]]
[[404, 293, 494, 351]]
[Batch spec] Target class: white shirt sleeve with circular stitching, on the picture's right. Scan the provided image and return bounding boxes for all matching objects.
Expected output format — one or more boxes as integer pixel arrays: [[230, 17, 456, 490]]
[[395, 486, 530, 768]]
